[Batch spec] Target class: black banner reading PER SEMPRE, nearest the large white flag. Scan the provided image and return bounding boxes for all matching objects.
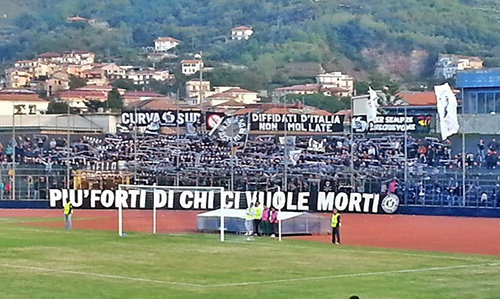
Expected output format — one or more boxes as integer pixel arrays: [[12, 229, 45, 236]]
[[353, 115, 432, 133]]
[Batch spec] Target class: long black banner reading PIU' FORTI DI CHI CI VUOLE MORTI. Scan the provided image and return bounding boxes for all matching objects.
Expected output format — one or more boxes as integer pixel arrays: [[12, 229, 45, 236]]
[[49, 188, 399, 214]]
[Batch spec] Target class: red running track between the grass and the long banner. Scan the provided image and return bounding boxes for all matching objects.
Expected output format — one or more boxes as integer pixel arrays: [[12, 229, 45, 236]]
[[0, 209, 500, 256]]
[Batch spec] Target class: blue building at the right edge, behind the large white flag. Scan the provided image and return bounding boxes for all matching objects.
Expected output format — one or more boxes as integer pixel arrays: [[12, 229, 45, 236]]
[[456, 68, 500, 114]]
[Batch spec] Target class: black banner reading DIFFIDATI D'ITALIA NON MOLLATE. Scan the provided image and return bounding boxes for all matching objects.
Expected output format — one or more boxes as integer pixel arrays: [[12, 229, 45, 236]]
[[250, 113, 344, 133]]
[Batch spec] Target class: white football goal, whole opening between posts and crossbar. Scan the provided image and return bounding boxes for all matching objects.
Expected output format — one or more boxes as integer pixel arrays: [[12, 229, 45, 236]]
[[118, 185, 226, 241]]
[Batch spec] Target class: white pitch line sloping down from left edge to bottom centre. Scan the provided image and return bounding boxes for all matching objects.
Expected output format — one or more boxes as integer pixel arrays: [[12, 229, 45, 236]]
[[0, 264, 205, 287]]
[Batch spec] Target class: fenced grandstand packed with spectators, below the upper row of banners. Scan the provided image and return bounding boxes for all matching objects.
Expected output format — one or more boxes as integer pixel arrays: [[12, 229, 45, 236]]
[[0, 134, 500, 212]]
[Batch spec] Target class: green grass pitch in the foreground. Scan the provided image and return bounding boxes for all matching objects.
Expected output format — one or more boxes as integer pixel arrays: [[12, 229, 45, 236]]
[[0, 219, 500, 299]]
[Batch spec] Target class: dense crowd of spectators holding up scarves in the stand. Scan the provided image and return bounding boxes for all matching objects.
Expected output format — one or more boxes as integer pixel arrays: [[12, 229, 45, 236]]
[[0, 134, 500, 207]]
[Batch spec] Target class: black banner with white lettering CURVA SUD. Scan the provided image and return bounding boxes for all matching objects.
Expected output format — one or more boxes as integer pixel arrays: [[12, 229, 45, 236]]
[[121, 110, 201, 127]]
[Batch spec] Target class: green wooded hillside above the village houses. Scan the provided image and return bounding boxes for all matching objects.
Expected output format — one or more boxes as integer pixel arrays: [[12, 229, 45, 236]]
[[0, 0, 500, 88]]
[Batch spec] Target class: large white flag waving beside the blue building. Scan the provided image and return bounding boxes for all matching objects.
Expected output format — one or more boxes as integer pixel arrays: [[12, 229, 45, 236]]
[[434, 83, 459, 140]]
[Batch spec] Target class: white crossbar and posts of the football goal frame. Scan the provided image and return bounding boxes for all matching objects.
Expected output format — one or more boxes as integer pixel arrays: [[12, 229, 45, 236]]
[[118, 184, 225, 242]]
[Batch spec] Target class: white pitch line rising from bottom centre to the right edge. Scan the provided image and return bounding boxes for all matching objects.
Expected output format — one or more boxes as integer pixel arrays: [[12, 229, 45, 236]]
[[207, 263, 500, 288]]
